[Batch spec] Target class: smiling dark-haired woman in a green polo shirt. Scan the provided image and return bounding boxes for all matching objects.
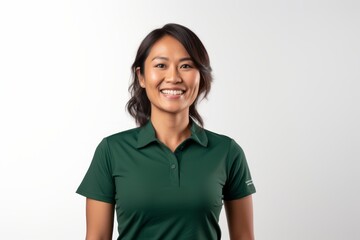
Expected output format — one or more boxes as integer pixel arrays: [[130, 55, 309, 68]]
[[77, 24, 255, 240]]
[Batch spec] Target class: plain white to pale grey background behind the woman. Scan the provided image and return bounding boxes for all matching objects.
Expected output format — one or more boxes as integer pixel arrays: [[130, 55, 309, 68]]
[[0, 0, 360, 240]]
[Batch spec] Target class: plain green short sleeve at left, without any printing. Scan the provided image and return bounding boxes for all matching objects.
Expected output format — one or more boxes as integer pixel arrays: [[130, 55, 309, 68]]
[[76, 138, 115, 204]]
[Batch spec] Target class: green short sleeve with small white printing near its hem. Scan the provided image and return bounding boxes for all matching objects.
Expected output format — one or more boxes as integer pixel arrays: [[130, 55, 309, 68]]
[[223, 140, 256, 200]]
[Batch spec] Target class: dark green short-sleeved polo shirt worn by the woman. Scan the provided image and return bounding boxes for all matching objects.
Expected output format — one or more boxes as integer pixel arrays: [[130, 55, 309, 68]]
[[77, 121, 255, 240]]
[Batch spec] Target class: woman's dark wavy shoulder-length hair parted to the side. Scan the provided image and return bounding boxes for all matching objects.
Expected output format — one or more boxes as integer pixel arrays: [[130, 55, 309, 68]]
[[126, 23, 212, 126]]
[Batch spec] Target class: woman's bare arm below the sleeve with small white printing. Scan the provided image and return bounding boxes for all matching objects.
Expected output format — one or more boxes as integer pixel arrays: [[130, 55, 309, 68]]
[[224, 195, 255, 240]]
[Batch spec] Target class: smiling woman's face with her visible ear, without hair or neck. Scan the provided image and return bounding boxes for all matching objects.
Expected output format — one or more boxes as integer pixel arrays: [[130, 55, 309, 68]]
[[137, 36, 200, 117]]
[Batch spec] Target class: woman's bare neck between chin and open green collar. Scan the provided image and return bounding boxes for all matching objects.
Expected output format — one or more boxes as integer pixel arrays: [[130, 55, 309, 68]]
[[150, 111, 191, 152]]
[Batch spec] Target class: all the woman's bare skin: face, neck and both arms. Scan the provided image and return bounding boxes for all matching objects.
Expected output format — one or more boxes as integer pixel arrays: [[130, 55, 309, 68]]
[[86, 36, 254, 240]]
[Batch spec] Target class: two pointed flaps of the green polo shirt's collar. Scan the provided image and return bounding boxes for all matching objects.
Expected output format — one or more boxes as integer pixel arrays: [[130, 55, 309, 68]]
[[136, 119, 208, 148]]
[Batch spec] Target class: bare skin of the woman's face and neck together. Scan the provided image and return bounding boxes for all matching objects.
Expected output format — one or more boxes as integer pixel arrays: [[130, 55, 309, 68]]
[[137, 36, 200, 151]]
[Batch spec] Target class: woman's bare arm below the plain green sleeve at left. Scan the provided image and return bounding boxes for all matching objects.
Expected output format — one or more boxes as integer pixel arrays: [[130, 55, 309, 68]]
[[86, 198, 114, 240]]
